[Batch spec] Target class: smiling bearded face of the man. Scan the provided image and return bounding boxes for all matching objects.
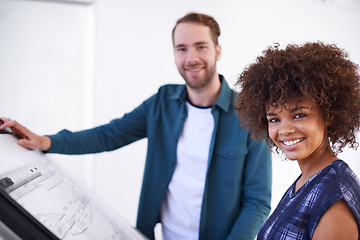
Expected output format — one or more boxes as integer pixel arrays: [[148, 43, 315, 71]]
[[174, 23, 221, 89]]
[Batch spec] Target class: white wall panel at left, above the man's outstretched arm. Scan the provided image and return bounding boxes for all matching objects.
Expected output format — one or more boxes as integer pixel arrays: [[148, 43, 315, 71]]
[[0, 0, 93, 186]]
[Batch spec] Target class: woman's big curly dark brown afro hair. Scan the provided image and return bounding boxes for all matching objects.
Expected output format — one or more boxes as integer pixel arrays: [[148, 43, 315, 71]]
[[235, 42, 360, 154]]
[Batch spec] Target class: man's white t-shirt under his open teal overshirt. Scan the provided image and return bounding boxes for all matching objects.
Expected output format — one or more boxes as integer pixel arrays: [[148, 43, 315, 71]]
[[161, 102, 214, 240]]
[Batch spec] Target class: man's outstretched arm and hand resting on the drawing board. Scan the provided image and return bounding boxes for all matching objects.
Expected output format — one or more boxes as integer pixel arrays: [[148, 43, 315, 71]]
[[0, 96, 154, 154]]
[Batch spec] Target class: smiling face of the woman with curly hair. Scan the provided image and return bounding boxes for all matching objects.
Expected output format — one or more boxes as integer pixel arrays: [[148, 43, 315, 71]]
[[266, 100, 329, 161]]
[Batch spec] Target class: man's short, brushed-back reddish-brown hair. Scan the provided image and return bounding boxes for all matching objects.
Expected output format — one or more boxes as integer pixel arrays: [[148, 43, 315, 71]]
[[172, 12, 220, 45]]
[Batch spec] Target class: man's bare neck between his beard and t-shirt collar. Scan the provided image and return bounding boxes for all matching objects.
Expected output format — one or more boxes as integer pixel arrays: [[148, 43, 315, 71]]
[[186, 74, 221, 107]]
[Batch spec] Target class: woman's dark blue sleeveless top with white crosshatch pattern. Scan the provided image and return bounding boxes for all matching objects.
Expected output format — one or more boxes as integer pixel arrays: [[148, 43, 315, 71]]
[[258, 160, 360, 240]]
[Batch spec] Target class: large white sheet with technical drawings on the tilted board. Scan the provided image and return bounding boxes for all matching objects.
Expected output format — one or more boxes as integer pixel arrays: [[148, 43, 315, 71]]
[[0, 134, 146, 240]]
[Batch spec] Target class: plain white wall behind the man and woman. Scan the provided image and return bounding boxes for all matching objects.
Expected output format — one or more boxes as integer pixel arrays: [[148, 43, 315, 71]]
[[0, 0, 360, 232]]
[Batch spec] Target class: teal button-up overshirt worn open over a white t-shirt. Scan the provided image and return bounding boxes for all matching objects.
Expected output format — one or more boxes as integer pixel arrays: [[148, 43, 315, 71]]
[[49, 75, 272, 240]]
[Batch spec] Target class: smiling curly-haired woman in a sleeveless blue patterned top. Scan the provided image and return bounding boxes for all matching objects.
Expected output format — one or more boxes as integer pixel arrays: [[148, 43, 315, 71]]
[[236, 42, 360, 240]]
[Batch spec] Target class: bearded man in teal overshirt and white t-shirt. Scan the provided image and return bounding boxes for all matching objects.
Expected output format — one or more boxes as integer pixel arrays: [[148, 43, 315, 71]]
[[0, 13, 271, 240]]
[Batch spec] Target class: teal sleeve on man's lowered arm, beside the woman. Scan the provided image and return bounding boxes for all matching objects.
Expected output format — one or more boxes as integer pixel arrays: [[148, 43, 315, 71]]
[[227, 139, 272, 240]]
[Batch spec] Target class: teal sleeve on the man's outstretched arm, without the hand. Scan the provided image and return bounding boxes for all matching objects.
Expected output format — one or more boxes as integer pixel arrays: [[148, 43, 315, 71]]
[[48, 96, 154, 154]]
